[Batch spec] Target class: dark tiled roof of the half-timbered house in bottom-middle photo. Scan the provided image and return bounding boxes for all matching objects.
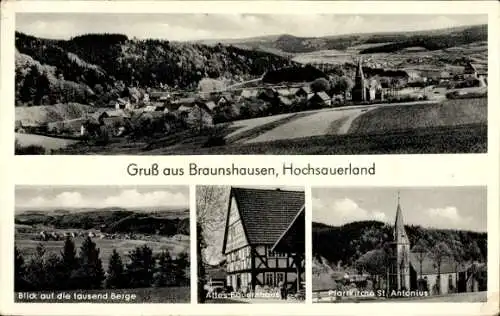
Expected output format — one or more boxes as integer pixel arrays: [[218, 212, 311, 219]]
[[231, 188, 305, 245]]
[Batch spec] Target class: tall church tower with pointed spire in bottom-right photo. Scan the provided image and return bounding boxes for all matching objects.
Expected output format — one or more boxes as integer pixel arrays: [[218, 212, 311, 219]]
[[394, 192, 410, 290]]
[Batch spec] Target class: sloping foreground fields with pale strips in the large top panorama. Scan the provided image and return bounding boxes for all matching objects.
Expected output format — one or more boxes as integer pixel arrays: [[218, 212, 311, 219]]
[[52, 98, 487, 155]]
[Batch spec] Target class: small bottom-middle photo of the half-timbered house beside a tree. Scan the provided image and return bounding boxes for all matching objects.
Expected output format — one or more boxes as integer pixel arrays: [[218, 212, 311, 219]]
[[196, 186, 306, 304]]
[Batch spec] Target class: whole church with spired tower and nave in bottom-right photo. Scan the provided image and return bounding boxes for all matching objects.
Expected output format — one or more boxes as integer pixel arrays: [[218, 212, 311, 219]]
[[388, 197, 483, 295]]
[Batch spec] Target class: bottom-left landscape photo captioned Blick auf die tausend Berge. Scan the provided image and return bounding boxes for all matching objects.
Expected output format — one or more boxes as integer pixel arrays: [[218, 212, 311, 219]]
[[14, 186, 191, 303]]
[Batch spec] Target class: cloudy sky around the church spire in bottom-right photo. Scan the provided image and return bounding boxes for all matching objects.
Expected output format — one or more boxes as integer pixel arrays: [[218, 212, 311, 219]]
[[312, 187, 487, 232]]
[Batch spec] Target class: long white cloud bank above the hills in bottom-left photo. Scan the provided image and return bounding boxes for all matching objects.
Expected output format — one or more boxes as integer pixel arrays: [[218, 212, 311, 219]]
[[16, 189, 189, 208]]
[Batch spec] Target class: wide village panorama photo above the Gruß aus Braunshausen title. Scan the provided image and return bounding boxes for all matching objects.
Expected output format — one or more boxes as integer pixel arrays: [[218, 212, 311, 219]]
[[14, 13, 488, 155]]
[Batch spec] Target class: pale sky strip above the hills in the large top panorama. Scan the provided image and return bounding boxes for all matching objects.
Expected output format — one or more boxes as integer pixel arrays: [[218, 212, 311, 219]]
[[16, 13, 487, 41]]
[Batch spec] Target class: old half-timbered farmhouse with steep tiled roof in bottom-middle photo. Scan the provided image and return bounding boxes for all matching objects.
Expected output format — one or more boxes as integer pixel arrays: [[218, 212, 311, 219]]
[[222, 188, 305, 292]]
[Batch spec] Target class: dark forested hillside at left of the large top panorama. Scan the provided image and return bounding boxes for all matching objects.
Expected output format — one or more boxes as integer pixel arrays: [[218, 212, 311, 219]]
[[16, 32, 291, 105]]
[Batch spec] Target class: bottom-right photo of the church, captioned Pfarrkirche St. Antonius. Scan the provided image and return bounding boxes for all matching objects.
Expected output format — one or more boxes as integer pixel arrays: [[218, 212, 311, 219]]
[[312, 187, 488, 303]]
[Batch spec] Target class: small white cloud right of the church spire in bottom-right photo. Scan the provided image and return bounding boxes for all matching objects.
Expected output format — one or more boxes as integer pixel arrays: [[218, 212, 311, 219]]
[[424, 206, 473, 229]]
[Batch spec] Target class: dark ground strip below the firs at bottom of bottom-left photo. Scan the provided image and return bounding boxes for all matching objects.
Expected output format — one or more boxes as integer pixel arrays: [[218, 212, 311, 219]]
[[15, 286, 191, 303]]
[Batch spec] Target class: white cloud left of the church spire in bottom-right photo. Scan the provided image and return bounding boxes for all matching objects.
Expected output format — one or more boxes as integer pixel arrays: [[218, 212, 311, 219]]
[[313, 198, 387, 226]]
